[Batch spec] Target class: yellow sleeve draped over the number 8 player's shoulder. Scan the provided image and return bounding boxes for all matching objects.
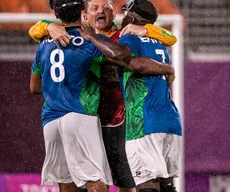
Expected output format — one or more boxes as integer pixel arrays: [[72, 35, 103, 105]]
[[29, 20, 52, 43]]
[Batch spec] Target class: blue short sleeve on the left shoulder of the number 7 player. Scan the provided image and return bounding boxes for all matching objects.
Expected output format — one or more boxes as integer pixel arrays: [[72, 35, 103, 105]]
[[117, 34, 141, 55]]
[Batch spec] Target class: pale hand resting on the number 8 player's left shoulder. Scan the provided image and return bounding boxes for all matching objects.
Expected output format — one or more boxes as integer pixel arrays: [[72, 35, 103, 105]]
[[47, 23, 71, 48]]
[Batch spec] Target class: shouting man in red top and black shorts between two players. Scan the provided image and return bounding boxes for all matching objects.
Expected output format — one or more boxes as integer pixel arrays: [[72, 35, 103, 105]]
[[81, 0, 175, 191]]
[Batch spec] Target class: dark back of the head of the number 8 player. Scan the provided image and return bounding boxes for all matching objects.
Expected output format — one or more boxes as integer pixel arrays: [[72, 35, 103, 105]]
[[52, 0, 84, 23]]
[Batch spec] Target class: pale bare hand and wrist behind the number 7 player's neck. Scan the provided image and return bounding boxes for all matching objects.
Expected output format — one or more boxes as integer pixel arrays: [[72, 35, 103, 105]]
[[119, 23, 147, 37]]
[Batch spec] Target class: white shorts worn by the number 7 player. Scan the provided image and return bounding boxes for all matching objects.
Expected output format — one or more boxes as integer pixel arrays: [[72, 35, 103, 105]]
[[126, 133, 180, 185]]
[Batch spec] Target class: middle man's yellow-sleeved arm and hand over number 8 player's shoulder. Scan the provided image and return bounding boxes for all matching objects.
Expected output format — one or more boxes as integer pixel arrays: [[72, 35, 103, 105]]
[[29, 20, 71, 46]]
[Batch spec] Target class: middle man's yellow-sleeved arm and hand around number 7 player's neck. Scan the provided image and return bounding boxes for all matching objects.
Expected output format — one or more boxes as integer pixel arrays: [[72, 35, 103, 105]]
[[120, 24, 177, 46]]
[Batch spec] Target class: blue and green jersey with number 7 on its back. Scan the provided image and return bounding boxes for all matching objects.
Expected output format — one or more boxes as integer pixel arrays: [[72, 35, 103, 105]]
[[118, 35, 182, 140]]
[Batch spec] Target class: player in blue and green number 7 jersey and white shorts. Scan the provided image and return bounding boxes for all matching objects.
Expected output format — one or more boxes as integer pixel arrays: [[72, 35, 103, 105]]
[[114, 0, 182, 192]]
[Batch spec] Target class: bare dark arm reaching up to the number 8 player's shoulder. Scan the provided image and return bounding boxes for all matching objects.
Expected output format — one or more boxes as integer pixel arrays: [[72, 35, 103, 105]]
[[77, 26, 131, 63]]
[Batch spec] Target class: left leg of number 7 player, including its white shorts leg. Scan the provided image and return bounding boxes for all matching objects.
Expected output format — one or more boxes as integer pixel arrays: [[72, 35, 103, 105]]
[[126, 134, 168, 191]]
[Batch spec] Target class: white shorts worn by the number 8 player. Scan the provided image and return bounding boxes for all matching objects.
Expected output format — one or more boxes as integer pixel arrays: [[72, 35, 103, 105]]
[[42, 113, 112, 187]]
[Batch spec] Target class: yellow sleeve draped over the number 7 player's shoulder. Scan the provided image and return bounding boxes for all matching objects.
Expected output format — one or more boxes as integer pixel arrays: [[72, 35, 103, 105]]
[[144, 24, 177, 46]]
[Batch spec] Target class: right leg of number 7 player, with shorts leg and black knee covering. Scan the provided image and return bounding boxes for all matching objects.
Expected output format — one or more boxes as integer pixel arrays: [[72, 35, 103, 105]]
[[160, 134, 181, 192]]
